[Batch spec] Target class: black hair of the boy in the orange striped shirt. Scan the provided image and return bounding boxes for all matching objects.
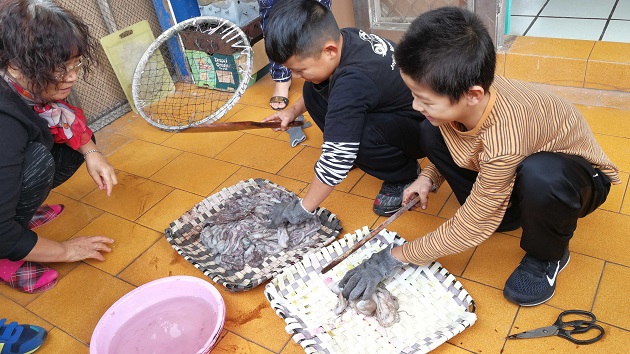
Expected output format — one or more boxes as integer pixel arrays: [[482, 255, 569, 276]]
[[395, 7, 496, 102]]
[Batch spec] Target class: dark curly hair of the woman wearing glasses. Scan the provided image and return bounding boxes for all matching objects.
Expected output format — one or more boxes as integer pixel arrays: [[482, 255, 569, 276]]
[[0, 0, 96, 94]]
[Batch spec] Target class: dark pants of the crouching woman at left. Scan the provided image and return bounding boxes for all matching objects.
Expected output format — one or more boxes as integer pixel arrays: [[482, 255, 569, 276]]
[[15, 142, 85, 228]]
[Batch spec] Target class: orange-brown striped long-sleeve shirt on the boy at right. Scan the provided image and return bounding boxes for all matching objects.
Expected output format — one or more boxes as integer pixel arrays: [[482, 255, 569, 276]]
[[403, 76, 620, 264]]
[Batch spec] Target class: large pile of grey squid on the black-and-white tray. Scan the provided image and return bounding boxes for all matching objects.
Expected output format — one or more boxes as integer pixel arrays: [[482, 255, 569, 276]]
[[200, 185, 321, 270]]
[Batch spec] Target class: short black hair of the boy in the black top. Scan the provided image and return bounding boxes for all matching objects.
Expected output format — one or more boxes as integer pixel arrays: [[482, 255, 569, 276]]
[[265, 0, 341, 64]]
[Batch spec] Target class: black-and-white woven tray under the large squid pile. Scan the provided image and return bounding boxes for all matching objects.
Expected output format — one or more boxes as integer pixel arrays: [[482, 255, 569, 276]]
[[165, 179, 341, 292]]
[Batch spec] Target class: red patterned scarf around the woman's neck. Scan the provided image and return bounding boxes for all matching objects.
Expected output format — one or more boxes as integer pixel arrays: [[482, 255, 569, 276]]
[[3, 72, 92, 150]]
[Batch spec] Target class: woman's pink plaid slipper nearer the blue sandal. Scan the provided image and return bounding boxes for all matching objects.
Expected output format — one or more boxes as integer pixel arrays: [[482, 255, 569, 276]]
[[0, 259, 59, 294]]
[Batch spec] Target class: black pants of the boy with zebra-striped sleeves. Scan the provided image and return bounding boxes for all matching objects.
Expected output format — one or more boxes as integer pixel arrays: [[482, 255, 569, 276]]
[[303, 82, 425, 183]]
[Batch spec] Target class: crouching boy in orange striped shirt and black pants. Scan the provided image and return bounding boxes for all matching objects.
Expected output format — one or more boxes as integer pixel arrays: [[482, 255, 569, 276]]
[[340, 7, 620, 306]]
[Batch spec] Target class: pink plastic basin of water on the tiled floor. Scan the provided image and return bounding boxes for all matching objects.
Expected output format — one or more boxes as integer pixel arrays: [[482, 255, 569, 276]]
[[90, 276, 225, 354]]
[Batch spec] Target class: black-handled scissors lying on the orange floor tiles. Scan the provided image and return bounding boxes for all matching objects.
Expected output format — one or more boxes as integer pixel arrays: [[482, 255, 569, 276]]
[[508, 310, 604, 344]]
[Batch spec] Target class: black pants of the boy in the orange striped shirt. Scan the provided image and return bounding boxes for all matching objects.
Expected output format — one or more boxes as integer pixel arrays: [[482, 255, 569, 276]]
[[421, 121, 610, 261]]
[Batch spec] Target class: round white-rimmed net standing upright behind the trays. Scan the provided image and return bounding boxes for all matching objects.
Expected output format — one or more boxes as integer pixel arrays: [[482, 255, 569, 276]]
[[133, 17, 252, 130]]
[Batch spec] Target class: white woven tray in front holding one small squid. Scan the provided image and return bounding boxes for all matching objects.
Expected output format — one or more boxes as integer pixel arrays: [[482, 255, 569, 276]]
[[265, 227, 477, 354]]
